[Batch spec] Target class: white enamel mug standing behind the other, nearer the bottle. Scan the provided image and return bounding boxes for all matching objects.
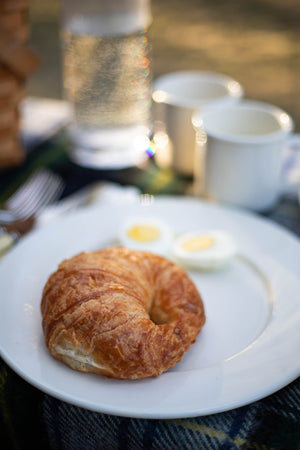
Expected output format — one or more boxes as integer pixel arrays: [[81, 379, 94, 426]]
[[152, 71, 243, 175]]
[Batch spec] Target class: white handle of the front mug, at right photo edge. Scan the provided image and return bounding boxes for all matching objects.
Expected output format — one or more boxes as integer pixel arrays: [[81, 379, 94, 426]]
[[280, 133, 300, 195]]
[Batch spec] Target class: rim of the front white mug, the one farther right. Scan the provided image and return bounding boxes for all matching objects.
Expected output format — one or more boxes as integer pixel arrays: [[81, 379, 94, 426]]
[[192, 100, 294, 144]]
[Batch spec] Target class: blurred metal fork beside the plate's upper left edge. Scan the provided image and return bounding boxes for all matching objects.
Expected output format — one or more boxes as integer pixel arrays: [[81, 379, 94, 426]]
[[0, 169, 64, 224]]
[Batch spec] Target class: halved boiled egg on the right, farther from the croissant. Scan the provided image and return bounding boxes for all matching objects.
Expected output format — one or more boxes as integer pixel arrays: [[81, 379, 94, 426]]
[[172, 230, 237, 270]]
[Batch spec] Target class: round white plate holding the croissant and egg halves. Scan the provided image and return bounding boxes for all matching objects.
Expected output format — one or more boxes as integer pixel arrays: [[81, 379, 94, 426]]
[[0, 198, 300, 418]]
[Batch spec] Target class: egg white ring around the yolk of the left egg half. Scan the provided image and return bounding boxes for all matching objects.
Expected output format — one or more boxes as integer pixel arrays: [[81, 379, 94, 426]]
[[118, 217, 173, 256]]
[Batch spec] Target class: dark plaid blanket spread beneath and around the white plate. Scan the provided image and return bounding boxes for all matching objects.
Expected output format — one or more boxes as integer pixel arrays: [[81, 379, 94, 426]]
[[0, 136, 300, 450]]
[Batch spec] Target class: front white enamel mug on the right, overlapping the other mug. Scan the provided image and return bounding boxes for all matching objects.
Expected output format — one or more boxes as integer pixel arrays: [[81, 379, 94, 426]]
[[192, 100, 300, 211]]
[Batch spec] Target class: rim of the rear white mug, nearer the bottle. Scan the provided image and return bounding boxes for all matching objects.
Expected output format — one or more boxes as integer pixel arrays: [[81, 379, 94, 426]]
[[152, 70, 244, 110]]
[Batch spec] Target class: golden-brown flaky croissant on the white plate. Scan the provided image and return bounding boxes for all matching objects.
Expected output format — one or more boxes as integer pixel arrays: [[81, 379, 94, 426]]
[[41, 247, 205, 379]]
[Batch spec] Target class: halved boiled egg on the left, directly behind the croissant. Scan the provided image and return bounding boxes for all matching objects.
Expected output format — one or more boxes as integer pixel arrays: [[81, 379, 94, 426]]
[[119, 217, 173, 256]]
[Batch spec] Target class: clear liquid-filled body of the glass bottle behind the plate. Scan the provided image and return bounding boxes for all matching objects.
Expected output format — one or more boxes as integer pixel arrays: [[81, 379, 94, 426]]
[[62, 17, 151, 168]]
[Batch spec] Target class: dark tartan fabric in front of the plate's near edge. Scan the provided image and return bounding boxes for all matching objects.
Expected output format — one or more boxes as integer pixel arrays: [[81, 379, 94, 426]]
[[0, 360, 300, 450]]
